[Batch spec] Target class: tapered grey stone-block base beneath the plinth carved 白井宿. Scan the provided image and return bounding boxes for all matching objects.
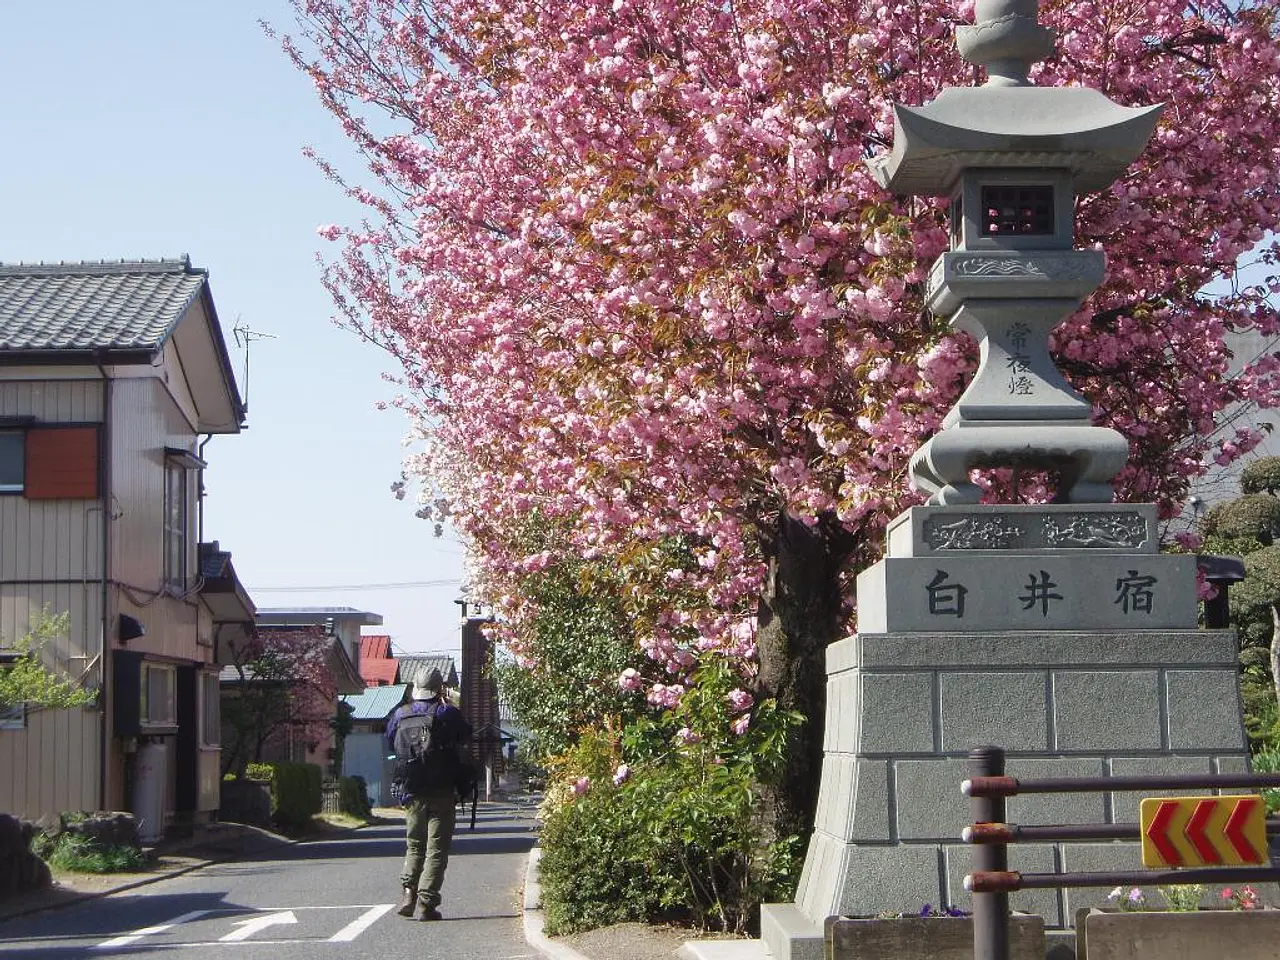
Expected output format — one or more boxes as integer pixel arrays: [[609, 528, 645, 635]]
[[788, 630, 1247, 942]]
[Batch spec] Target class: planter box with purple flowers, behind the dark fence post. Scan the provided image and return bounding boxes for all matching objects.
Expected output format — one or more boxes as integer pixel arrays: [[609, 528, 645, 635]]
[[823, 914, 1044, 960]]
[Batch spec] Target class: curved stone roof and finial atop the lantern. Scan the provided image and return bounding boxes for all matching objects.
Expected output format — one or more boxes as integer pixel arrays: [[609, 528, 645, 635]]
[[869, 0, 1164, 196]]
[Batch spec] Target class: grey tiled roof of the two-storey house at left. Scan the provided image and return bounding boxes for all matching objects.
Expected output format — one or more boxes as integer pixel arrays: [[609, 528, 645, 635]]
[[0, 257, 207, 351]]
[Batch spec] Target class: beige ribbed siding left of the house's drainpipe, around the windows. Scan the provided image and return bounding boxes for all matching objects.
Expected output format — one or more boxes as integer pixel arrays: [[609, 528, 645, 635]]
[[0, 367, 104, 818]]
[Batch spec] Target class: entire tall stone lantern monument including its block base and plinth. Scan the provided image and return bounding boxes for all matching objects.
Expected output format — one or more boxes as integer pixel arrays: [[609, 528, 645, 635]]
[[760, 0, 1248, 960]]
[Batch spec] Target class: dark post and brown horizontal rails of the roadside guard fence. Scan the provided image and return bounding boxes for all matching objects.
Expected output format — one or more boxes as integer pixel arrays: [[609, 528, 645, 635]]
[[960, 746, 1280, 960]]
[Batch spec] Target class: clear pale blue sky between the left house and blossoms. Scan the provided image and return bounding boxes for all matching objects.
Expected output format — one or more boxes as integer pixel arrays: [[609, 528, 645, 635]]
[[0, 0, 463, 652]]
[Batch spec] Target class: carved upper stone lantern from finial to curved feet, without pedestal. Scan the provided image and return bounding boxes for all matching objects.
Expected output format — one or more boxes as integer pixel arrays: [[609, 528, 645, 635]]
[[872, 0, 1161, 504]]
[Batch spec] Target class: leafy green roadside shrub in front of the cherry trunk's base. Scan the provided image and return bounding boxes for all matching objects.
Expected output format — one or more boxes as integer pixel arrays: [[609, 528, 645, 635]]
[[540, 658, 803, 933]]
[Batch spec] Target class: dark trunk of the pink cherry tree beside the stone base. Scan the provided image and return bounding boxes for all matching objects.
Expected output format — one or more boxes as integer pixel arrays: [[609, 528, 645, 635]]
[[758, 515, 849, 837]]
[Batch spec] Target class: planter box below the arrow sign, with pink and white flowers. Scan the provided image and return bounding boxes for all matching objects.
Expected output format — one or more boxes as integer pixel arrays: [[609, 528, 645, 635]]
[[1075, 910, 1280, 960]]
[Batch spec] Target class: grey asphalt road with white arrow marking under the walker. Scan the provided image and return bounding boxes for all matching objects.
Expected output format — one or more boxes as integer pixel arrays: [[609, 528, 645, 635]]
[[0, 803, 538, 960]]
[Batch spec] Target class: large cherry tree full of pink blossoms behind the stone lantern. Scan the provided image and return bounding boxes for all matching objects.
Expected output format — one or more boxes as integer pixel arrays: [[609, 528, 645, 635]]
[[284, 0, 1280, 826]]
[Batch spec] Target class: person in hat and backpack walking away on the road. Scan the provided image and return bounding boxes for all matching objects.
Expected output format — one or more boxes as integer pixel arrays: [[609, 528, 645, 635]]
[[387, 668, 471, 920]]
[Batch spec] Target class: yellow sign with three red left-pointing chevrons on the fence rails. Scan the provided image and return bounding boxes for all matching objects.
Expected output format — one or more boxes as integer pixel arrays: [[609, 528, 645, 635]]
[[1142, 795, 1270, 867]]
